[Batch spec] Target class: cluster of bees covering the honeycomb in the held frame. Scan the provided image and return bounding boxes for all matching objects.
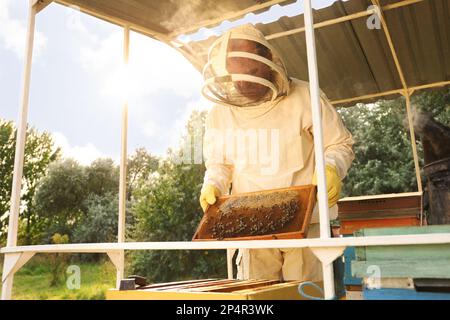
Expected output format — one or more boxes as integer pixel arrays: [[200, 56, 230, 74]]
[[205, 191, 300, 240]]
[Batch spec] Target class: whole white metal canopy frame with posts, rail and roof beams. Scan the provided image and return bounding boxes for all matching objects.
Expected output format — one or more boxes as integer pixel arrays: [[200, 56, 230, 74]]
[[0, 0, 450, 299]]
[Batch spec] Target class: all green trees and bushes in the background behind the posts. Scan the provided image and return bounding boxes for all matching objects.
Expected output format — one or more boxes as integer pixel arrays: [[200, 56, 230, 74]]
[[0, 88, 450, 288]]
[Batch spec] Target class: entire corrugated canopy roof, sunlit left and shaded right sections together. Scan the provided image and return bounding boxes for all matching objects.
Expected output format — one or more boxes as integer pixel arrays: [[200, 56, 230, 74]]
[[51, 0, 450, 106]]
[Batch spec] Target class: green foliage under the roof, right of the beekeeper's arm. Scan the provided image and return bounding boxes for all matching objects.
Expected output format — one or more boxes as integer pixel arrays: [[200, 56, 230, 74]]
[[339, 88, 450, 196]]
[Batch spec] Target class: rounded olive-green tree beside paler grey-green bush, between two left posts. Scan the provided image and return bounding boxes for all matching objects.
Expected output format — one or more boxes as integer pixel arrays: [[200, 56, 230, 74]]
[[34, 159, 119, 242]]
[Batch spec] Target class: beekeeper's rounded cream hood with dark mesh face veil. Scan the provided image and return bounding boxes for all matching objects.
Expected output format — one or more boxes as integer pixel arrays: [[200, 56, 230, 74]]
[[202, 24, 289, 107]]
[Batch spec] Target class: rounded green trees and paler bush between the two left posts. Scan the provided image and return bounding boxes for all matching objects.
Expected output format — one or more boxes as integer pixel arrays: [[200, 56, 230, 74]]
[[34, 159, 124, 243]]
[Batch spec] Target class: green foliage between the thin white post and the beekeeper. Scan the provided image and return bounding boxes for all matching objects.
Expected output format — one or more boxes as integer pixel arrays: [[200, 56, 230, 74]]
[[131, 113, 226, 282]]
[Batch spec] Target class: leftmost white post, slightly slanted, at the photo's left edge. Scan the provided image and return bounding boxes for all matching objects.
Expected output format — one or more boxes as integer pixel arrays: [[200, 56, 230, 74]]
[[2, 0, 36, 300]]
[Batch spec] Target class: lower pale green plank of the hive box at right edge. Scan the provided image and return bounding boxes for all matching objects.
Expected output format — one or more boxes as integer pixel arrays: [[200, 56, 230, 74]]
[[352, 259, 450, 279]]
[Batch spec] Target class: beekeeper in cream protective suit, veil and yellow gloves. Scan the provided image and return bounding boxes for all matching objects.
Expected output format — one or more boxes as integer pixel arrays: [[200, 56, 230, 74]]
[[200, 24, 354, 281]]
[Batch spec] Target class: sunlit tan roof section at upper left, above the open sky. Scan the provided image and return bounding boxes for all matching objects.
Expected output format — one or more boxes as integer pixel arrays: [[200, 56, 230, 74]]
[[51, 0, 295, 40]]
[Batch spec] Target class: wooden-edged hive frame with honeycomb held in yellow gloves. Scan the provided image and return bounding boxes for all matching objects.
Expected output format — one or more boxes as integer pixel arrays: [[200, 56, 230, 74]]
[[192, 185, 316, 241]]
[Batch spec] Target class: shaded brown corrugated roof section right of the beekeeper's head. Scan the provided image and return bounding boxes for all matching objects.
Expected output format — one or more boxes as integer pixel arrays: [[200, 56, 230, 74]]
[[181, 0, 450, 105]]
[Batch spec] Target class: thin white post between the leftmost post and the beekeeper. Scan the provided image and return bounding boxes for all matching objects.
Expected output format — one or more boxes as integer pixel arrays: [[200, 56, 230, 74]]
[[116, 26, 130, 288]]
